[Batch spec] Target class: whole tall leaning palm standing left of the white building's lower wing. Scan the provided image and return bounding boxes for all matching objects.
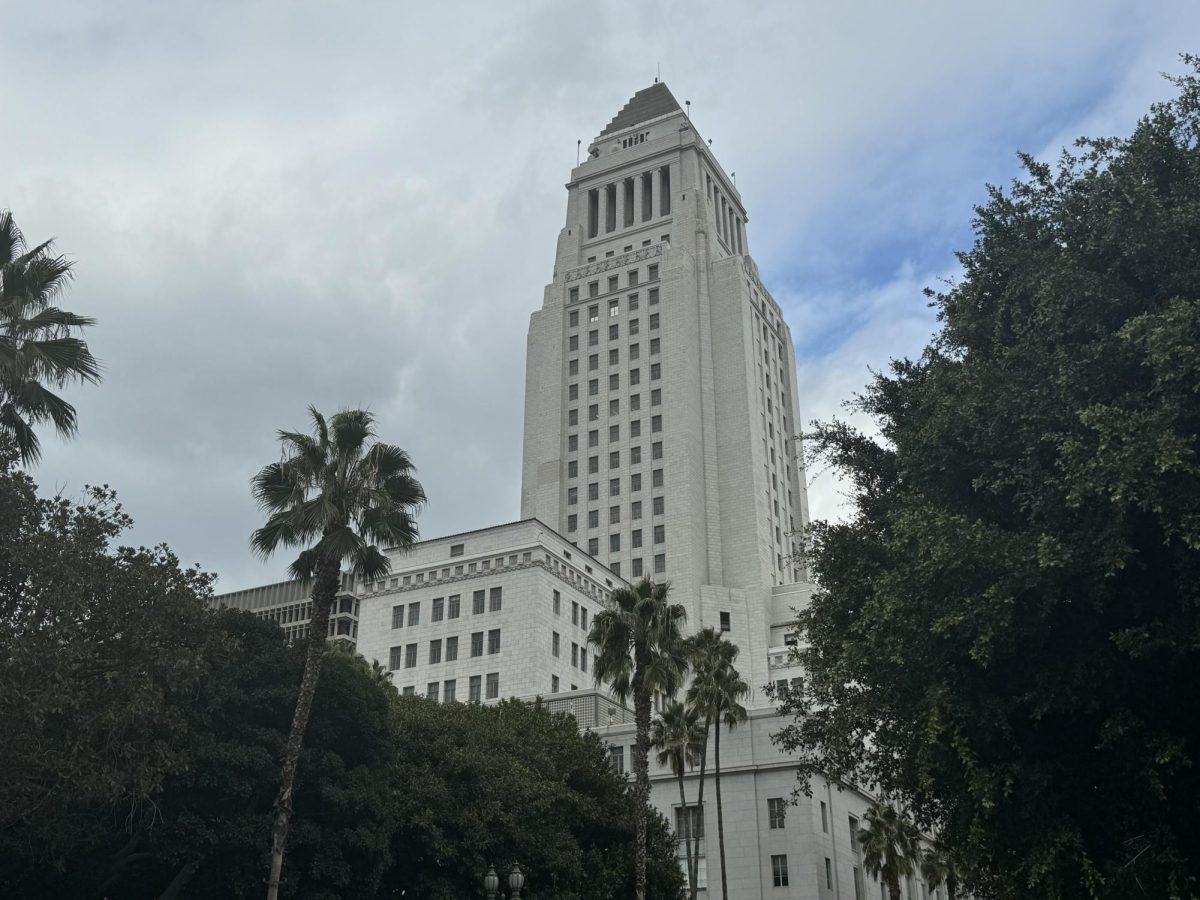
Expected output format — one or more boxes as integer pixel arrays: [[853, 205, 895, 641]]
[[250, 407, 425, 900]]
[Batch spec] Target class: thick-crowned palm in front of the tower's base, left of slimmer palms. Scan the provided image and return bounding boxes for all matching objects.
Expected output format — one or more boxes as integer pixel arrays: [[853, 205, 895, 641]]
[[588, 578, 688, 900]]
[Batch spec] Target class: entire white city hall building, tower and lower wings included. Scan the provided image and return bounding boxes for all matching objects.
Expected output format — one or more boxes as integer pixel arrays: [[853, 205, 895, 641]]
[[217, 82, 941, 900]]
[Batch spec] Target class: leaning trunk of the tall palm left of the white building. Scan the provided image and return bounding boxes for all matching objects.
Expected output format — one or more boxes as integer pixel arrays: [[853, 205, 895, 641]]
[[266, 560, 341, 900]]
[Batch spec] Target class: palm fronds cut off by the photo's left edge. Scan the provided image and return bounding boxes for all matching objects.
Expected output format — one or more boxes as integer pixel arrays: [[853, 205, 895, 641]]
[[0, 210, 100, 464]]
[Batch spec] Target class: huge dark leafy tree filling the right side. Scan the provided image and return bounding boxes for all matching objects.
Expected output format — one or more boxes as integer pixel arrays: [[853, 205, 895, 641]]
[[779, 58, 1200, 898]]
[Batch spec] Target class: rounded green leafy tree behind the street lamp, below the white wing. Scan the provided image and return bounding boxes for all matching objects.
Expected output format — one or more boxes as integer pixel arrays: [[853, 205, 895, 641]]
[[379, 697, 684, 900]]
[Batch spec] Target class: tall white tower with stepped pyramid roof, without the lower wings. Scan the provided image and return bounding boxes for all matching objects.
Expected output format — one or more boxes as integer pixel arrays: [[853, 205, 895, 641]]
[[521, 83, 808, 691]]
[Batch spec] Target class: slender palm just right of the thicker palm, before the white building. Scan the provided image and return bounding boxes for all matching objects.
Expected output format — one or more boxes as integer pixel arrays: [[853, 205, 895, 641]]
[[688, 626, 750, 900]]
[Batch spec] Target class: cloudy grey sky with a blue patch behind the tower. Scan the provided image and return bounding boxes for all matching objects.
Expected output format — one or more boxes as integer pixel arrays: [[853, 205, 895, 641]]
[[0, 0, 1200, 590]]
